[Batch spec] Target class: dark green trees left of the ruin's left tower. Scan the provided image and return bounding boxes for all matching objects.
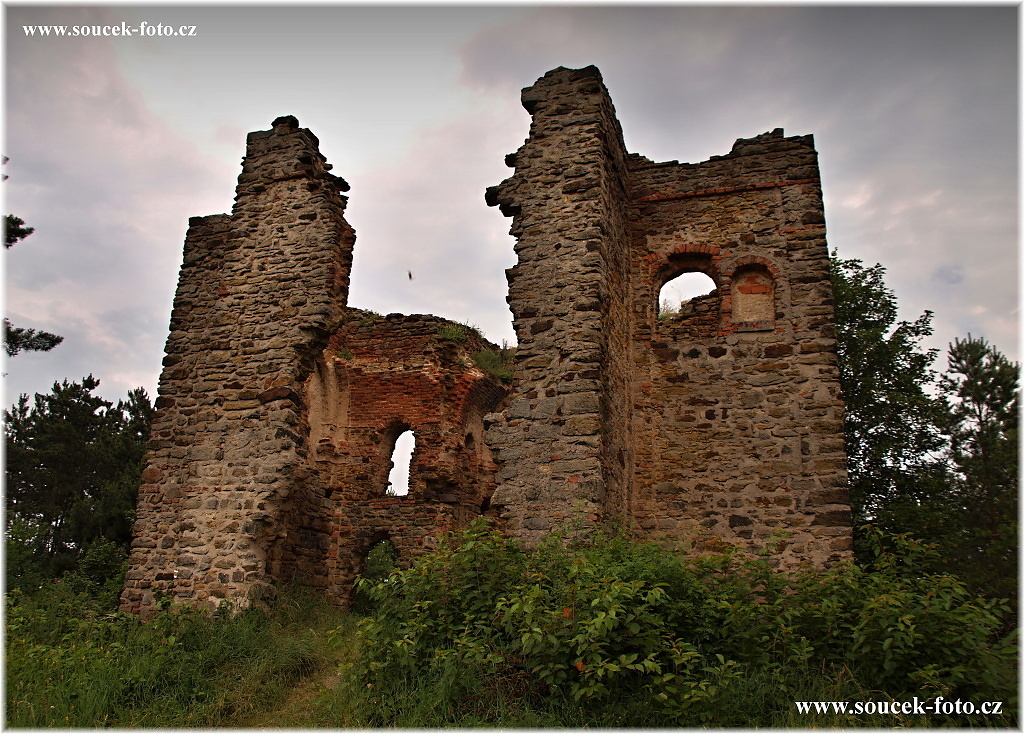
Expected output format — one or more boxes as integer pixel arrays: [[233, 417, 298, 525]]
[[4, 375, 153, 584]]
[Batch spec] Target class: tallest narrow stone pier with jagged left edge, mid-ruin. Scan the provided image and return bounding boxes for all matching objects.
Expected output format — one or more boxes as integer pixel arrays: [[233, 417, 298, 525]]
[[487, 67, 631, 544]]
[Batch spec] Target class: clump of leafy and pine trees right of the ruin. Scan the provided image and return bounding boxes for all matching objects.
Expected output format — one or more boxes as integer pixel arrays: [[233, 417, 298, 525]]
[[831, 254, 1019, 600]]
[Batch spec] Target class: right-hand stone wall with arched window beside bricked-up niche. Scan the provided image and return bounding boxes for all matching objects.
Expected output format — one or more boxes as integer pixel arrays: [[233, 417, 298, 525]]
[[631, 130, 852, 564]]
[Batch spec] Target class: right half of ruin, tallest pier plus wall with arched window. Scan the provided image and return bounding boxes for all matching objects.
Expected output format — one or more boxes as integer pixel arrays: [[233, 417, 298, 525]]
[[487, 67, 851, 565]]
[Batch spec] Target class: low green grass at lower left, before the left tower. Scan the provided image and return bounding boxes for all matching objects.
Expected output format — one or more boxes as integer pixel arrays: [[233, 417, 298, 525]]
[[5, 582, 347, 728]]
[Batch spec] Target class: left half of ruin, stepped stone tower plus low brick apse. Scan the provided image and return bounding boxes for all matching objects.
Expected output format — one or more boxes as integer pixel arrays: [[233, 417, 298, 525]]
[[122, 117, 506, 614]]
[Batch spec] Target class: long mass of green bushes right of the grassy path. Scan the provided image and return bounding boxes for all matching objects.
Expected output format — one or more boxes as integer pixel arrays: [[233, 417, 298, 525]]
[[344, 523, 1017, 727]]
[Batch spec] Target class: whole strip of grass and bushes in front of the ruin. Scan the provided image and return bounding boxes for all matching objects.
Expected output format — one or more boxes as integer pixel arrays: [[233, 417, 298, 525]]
[[6, 525, 1017, 728]]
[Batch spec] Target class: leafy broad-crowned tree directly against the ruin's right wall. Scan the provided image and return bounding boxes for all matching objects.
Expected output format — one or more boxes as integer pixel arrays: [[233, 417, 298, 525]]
[[830, 253, 945, 525]]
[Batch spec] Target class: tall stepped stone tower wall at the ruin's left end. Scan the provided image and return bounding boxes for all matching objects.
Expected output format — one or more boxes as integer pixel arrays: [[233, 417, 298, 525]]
[[122, 118, 354, 611]]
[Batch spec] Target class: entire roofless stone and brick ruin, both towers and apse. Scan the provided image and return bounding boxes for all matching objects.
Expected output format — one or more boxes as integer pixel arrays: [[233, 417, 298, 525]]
[[122, 67, 852, 614]]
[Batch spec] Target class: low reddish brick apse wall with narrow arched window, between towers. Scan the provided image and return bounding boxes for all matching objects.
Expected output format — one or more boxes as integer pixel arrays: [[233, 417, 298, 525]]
[[282, 309, 506, 599]]
